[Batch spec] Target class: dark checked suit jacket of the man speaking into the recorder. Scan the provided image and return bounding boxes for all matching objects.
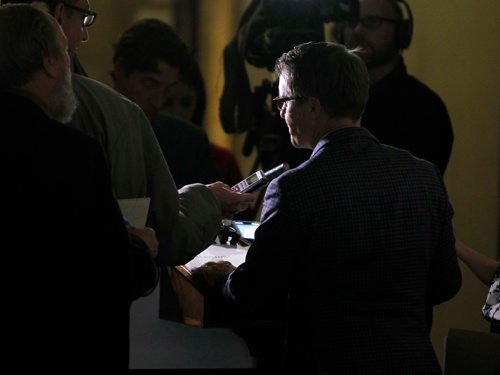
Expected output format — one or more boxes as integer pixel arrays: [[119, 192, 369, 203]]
[[223, 127, 461, 374]]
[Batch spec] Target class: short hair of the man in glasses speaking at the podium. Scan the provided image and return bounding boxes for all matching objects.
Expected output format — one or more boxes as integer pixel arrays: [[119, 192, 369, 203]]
[[275, 42, 370, 120]]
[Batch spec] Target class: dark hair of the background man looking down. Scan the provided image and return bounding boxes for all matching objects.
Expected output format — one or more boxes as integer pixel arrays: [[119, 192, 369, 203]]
[[113, 18, 193, 75]]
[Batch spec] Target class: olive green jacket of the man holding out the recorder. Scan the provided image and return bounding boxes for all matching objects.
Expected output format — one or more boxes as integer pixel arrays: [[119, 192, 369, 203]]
[[69, 74, 221, 265]]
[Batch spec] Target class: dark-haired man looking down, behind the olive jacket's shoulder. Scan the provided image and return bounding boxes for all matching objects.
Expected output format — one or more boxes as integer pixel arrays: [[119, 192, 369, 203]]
[[111, 19, 218, 187]]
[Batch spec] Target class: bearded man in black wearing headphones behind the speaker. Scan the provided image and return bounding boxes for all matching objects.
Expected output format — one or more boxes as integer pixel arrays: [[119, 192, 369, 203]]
[[333, 0, 453, 174]]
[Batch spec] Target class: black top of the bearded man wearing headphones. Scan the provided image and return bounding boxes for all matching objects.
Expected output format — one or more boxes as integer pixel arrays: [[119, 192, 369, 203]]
[[361, 60, 454, 175]]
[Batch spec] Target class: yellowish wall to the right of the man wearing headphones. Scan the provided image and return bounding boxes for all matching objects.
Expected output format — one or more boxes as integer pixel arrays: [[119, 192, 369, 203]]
[[407, 0, 500, 364]]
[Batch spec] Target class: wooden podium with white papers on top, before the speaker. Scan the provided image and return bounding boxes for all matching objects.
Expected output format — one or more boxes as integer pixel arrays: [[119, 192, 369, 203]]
[[168, 245, 248, 327]]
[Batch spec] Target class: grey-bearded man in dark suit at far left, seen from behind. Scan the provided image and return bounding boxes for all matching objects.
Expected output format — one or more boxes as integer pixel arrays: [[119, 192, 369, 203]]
[[0, 4, 157, 374]]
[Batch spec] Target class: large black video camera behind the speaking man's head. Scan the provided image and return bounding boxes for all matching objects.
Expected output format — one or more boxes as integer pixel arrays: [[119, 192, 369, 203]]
[[219, 0, 359, 170]]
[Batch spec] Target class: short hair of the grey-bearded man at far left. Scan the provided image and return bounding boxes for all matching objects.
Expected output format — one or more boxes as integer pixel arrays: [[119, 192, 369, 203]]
[[0, 4, 61, 89]]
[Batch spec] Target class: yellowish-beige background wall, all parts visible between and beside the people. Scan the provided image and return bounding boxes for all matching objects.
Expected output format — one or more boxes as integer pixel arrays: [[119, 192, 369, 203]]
[[80, 0, 500, 368]]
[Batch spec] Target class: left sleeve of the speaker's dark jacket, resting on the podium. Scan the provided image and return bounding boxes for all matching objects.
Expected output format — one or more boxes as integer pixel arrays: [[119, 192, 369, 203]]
[[223, 180, 296, 319]]
